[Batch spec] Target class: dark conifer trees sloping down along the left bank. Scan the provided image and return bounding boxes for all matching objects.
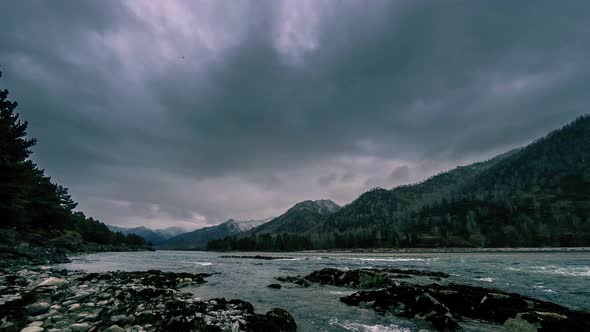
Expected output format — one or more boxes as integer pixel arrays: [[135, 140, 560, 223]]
[[0, 73, 145, 246]]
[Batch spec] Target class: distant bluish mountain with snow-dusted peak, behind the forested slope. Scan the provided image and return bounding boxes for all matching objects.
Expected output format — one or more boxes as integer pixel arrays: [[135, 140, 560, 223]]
[[157, 218, 271, 249]]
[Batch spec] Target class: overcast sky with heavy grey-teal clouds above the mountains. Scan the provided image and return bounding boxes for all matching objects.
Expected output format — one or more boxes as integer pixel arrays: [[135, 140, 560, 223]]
[[0, 0, 590, 228]]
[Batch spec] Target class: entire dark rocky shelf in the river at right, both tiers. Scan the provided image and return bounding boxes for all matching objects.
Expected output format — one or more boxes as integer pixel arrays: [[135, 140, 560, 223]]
[[276, 268, 590, 331]]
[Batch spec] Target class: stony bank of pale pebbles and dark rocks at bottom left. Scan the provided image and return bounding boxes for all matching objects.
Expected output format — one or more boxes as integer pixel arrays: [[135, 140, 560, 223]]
[[0, 267, 296, 332]]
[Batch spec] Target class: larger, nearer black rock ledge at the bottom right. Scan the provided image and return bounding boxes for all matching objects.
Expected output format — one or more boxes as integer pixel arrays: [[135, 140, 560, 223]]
[[340, 283, 590, 331]]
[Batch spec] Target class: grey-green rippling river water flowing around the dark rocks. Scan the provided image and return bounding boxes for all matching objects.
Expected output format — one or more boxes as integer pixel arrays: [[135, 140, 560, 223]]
[[63, 251, 590, 332]]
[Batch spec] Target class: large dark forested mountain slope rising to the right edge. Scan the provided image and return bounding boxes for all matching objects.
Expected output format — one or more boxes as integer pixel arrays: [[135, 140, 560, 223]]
[[209, 115, 590, 250]]
